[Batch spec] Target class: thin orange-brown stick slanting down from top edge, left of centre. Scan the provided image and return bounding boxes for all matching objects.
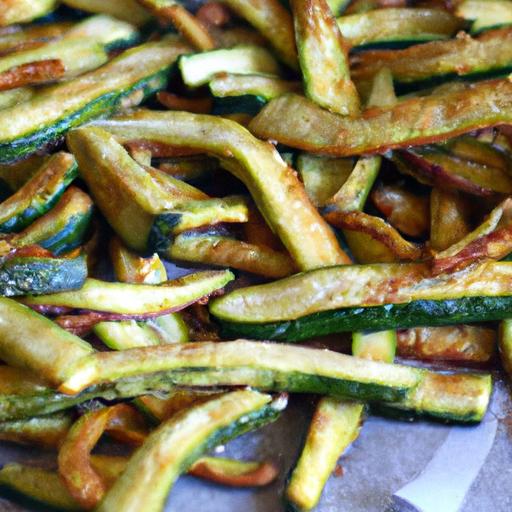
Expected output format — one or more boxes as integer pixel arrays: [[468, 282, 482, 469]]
[[139, 0, 215, 51]]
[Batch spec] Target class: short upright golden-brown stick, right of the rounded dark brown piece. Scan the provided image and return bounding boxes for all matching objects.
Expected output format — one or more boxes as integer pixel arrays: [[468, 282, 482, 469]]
[[430, 188, 471, 251]]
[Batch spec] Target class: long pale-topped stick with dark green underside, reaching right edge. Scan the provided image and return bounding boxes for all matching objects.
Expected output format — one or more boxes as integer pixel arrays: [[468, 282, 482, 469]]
[[210, 262, 512, 341]]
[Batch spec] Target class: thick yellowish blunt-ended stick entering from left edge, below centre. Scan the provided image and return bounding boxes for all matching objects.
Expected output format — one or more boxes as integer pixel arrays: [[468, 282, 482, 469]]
[[0, 298, 93, 384]]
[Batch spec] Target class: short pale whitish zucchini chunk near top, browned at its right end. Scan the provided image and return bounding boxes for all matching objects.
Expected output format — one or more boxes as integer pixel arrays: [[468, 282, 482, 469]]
[[178, 46, 279, 87]]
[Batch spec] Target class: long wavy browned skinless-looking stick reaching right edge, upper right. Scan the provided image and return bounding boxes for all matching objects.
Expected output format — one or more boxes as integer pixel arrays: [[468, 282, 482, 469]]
[[249, 78, 512, 156]]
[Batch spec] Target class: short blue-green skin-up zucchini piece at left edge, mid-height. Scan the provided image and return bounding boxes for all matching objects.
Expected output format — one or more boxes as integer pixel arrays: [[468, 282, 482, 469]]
[[0, 255, 87, 297]]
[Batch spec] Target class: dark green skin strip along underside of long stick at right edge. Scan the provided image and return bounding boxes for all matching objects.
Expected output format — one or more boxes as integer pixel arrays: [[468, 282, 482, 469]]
[[217, 296, 512, 342]]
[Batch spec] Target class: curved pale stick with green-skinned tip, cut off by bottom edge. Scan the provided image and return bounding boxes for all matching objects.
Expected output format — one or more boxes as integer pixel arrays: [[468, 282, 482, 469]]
[[97, 391, 279, 512]]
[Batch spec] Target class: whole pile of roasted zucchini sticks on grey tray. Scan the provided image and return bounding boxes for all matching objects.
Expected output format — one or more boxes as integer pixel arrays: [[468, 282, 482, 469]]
[[0, 0, 512, 512]]
